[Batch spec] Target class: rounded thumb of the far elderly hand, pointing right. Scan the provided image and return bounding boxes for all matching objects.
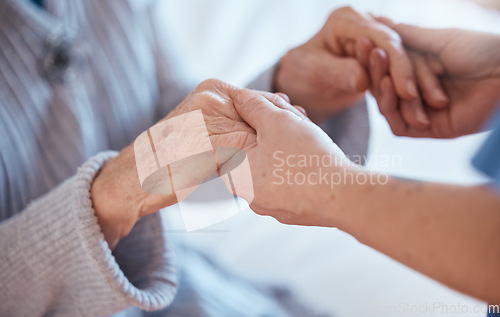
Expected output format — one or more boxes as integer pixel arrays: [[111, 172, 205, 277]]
[[311, 51, 369, 92]]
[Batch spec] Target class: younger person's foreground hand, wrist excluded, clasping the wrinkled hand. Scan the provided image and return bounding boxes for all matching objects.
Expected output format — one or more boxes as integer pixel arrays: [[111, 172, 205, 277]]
[[226, 90, 357, 226]]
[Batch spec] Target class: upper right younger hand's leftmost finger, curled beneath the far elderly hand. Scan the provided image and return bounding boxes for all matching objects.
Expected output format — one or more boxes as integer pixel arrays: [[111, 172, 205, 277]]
[[377, 76, 407, 135]]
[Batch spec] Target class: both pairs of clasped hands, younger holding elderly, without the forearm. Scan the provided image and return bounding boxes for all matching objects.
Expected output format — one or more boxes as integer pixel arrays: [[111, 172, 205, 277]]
[[91, 7, 500, 246]]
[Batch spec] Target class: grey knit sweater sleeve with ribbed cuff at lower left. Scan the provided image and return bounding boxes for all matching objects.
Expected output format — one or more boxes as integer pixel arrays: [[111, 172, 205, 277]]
[[0, 152, 177, 316]]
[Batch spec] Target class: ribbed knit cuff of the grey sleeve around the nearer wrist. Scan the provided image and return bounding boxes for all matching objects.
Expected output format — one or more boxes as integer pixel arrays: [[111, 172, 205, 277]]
[[74, 152, 177, 310]]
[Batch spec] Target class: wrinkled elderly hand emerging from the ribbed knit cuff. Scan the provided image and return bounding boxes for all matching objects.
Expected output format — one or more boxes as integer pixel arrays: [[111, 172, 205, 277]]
[[91, 80, 266, 247]]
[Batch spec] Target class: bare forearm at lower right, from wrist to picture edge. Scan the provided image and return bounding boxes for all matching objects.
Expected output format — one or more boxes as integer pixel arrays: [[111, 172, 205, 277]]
[[324, 172, 500, 303]]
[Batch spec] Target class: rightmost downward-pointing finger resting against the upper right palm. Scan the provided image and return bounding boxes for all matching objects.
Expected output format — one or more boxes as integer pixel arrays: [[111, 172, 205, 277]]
[[409, 52, 448, 109]]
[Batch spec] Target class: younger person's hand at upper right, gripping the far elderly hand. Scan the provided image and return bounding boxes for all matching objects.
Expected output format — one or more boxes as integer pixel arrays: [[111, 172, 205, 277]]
[[370, 19, 500, 138]]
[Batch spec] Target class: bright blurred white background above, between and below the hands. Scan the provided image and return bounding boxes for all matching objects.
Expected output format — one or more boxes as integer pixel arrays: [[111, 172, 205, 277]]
[[156, 0, 500, 316]]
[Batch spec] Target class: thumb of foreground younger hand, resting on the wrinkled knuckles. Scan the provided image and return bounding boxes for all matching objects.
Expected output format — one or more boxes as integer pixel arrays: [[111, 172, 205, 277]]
[[230, 89, 282, 131]]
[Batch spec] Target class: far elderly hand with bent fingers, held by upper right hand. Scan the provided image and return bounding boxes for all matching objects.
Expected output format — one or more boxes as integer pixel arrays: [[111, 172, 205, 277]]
[[274, 7, 428, 126]]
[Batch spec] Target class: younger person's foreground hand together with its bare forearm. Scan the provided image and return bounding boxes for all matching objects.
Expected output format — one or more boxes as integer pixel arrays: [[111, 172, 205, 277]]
[[226, 90, 500, 303]]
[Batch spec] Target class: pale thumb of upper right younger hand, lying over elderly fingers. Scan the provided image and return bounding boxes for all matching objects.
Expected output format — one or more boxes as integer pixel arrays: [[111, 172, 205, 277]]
[[393, 23, 450, 54]]
